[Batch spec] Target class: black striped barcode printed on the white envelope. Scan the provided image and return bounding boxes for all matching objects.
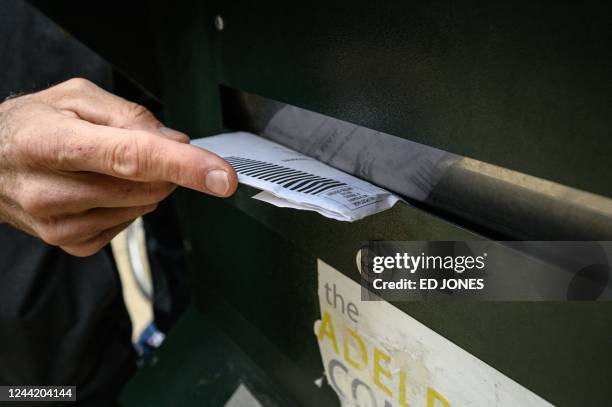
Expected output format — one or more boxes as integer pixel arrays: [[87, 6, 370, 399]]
[[223, 156, 348, 195]]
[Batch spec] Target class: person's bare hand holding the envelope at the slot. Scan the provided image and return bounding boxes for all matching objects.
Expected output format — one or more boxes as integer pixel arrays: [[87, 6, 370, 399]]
[[0, 79, 237, 256]]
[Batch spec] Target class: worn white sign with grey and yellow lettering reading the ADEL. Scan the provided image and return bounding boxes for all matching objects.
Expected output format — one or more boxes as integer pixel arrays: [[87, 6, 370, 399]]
[[314, 260, 551, 407]]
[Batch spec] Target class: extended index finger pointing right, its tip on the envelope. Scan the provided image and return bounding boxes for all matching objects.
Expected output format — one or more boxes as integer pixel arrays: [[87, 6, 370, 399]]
[[48, 118, 238, 196]]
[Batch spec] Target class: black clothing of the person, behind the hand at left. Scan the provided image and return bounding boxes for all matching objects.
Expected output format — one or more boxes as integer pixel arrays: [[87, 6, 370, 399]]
[[0, 0, 135, 405]]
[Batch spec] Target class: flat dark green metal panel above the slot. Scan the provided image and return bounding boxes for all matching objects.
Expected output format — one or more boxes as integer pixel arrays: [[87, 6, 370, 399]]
[[207, 0, 612, 201]]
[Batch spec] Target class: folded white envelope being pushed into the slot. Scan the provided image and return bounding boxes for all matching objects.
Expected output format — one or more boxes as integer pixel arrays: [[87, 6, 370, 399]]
[[192, 132, 400, 222]]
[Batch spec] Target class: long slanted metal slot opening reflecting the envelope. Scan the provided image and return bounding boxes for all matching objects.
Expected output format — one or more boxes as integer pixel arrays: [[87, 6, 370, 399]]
[[219, 86, 612, 240]]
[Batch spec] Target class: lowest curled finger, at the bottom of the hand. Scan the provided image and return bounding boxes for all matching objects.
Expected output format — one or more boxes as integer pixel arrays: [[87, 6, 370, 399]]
[[35, 205, 157, 250]]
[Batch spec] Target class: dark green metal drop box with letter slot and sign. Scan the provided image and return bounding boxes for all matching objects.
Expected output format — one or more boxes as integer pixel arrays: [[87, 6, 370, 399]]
[[34, 1, 612, 406]]
